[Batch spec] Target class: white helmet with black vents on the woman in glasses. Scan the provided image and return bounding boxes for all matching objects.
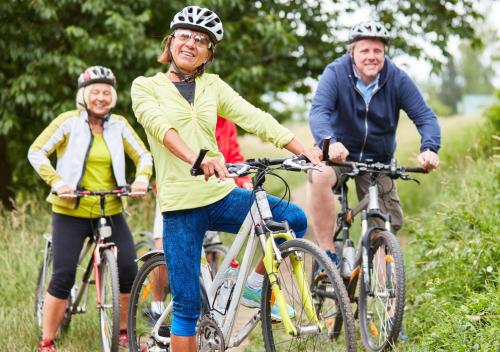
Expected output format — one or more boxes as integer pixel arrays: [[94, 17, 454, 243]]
[[170, 6, 224, 43]]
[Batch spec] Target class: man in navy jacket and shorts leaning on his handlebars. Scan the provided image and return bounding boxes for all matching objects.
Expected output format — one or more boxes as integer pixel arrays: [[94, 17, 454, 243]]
[[307, 21, 440, 340]]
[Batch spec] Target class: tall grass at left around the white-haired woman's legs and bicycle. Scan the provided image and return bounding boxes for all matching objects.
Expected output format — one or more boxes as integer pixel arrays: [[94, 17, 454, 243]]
[[0, 192, 154, 352]]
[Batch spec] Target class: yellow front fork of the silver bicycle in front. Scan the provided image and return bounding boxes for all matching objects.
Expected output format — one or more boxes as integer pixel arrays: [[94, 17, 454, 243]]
[[264, 233, 322, 336]]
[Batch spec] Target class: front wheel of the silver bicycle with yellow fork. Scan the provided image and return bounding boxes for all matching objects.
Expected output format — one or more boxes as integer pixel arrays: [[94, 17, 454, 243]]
[[261, 239, 356, 352]]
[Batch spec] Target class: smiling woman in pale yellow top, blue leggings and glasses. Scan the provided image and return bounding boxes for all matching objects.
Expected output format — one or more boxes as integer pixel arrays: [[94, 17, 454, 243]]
[[131, 6, 321, 352]]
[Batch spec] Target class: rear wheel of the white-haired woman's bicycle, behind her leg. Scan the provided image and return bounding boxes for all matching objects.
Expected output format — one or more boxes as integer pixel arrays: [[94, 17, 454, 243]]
[[35, 244, 72, 336]]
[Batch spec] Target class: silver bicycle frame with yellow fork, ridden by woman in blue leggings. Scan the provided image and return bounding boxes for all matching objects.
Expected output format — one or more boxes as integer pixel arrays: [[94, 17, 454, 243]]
[[152, 187, 322, 348]]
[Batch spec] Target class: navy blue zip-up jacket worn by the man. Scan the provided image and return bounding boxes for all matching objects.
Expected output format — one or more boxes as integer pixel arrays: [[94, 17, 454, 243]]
[[309, 53, 441, 162]]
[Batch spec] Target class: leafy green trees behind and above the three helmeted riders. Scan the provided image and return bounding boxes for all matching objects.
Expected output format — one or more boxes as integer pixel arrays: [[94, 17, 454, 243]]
[[0, 0, 480, 206]]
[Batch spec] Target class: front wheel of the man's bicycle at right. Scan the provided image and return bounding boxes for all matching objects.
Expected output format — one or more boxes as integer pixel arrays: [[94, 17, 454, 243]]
[[359, 230, 405, 352]]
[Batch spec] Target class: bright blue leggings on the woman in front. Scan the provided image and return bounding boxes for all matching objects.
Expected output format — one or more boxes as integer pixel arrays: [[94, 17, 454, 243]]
[[163, 188, 307, 336]]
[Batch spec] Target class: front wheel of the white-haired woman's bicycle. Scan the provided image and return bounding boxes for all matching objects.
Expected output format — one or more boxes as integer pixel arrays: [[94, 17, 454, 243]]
[[98, 249, 120, 352]]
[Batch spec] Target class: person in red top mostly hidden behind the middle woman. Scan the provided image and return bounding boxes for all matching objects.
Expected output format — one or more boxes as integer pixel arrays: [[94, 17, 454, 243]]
[[149, 116, 252, 321]]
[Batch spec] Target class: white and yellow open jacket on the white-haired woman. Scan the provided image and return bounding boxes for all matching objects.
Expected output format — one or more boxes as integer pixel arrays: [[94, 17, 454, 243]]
[[28, 110, 153, 208]]
